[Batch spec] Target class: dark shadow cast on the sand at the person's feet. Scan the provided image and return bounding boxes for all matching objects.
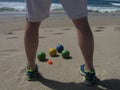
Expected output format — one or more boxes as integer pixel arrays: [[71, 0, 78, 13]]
[[35, 75, 120, 90]]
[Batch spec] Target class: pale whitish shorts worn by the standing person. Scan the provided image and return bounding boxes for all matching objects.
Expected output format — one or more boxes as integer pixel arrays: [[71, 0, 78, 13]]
[[26, 0, 87, 22]]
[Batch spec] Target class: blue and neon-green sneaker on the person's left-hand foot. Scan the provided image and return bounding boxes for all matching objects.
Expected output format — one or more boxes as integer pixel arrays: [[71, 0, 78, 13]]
[[26, 65, 39, 81]]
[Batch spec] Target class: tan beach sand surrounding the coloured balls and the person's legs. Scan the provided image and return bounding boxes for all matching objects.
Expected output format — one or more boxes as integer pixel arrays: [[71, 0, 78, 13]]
[[0, 14, 120, 90]]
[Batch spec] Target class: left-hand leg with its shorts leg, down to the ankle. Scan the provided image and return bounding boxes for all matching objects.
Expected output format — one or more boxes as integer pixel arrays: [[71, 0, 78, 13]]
[[24, 0, 51, 69]]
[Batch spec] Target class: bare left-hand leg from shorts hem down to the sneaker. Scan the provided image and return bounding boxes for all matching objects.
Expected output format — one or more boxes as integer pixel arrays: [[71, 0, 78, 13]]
[[24, 21, 40, 69]]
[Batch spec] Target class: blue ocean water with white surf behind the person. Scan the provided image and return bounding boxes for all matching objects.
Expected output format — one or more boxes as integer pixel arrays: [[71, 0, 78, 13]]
[[0, 0, 120, 13]]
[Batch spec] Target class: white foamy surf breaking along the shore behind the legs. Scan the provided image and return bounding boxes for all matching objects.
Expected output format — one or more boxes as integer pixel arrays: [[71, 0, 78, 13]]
[[0, 2, 120, 13]]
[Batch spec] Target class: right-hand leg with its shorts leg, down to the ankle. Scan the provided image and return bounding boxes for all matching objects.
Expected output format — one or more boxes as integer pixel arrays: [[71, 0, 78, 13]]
[[61, 0, 94, 69]]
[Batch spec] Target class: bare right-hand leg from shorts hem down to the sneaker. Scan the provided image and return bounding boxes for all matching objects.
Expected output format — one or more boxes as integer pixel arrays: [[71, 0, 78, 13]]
[[73, 17, 94, 70]]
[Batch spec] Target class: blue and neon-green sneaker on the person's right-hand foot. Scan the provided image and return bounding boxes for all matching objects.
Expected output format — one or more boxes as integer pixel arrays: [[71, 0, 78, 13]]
[[79, 64, 96, 86]]
